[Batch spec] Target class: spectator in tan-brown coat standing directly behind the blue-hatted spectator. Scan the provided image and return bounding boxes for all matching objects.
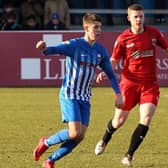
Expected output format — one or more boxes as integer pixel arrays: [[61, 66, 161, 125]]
[[44, 0, 70, 28]]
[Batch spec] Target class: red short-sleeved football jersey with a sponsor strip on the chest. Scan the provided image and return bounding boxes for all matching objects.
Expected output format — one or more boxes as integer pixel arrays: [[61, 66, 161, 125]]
[[112, 26, 168, 81]]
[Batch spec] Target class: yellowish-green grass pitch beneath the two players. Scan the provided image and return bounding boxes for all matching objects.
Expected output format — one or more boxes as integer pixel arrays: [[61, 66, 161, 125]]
[[0, 88, 168, 168]]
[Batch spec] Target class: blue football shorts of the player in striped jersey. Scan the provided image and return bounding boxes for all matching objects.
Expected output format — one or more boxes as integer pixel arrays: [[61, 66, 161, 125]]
[[60, 97, 90, 126]]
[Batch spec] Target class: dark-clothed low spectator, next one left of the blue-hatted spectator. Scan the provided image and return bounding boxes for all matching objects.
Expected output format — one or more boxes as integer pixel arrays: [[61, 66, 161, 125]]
[[23, 15, 42, 30]]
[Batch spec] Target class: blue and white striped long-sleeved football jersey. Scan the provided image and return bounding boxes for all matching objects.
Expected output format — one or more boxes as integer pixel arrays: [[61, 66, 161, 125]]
[[44, 37, 120, 101]]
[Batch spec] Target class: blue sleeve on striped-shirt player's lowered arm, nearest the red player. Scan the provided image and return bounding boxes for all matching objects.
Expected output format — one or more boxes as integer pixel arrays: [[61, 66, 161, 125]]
[[99, 48, 121, 94]]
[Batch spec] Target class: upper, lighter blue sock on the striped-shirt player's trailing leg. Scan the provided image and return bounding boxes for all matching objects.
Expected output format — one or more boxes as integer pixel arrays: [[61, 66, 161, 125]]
[[46, 129, 70, 146]]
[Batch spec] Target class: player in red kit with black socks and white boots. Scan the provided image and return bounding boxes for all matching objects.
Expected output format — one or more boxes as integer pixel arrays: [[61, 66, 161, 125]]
[[95, 4, 168, 166]]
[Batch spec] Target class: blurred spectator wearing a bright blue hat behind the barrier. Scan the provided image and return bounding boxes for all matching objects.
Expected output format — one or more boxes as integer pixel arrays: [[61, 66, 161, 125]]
[[45, 13, 67, 30]]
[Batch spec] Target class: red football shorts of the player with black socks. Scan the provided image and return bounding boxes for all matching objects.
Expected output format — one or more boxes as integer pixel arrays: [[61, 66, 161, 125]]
[[120, 80, 160, 111]]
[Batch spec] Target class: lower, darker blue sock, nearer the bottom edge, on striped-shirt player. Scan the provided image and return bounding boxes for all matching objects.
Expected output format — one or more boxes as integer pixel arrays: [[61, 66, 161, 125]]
[[48, 140, 80, 162]]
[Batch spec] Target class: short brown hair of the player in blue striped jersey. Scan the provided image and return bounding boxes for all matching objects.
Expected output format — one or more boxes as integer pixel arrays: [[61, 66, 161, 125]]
[[83, 13, 102, 24]]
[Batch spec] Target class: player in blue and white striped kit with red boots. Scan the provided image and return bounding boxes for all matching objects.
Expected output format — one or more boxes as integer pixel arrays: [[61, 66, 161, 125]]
[[33, 13, 123, 168]]
